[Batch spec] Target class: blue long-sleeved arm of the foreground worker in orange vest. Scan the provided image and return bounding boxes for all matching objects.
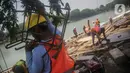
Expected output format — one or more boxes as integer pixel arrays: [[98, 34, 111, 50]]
[[26, 45, 51, 73]]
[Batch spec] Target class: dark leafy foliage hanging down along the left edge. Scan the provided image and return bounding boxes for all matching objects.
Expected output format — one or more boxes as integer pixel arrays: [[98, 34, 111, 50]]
[[0, 0, 18, 39]]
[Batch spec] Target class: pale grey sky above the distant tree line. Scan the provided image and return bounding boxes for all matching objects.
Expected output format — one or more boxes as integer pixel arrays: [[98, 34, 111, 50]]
[[17, 0, 113, 23]]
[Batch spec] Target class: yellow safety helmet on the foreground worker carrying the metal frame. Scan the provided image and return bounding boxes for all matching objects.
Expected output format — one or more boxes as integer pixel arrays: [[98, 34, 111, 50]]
[[25, 13, 46, 29]]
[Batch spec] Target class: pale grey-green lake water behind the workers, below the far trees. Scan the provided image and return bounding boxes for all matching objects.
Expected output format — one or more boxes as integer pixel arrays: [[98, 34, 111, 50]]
[[0, 11, 116, 69]]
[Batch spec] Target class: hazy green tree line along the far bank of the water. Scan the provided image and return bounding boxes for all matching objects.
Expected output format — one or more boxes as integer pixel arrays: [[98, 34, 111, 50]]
[[70, 0, 130, 21]]
